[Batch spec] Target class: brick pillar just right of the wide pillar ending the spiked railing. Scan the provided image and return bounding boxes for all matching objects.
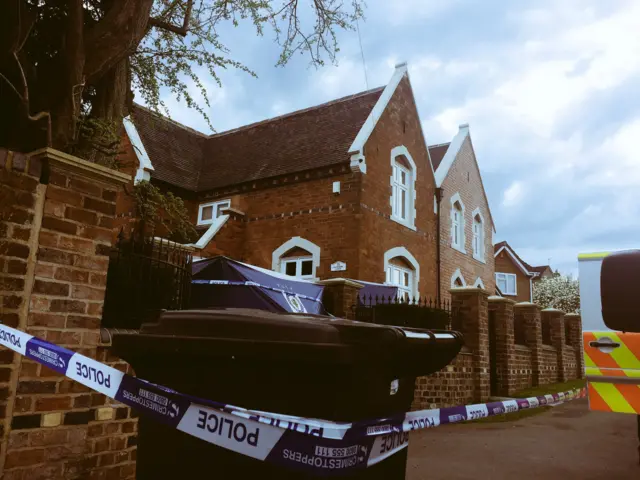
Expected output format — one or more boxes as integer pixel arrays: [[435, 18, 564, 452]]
[[489, 296, 516, 395]]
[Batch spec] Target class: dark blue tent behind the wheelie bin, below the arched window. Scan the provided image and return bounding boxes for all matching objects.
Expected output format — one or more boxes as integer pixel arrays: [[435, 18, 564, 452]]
[[191, 256, 327, 315]]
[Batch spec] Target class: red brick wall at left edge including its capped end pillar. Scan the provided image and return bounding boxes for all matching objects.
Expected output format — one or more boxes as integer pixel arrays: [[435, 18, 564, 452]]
[[0, 152, 135, 480]]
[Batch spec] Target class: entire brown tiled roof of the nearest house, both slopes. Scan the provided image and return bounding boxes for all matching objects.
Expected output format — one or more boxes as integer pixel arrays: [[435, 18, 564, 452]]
[[127, 87, 384, 192]]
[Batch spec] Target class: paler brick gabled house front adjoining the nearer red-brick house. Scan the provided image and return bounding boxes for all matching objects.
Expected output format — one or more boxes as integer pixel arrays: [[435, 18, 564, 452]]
[[429, 124, 495, 298]]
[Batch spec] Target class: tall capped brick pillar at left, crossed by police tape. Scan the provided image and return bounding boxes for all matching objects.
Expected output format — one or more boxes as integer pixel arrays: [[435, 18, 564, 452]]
[[1, 149, 135, 480]]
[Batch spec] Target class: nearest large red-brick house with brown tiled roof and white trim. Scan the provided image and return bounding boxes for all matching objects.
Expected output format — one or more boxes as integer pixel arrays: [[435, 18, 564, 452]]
[[117, 64, 438, 297]]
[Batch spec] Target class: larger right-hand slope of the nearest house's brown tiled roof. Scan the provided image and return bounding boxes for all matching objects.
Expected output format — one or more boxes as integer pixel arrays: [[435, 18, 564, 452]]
[[198, 88, 383, 191]]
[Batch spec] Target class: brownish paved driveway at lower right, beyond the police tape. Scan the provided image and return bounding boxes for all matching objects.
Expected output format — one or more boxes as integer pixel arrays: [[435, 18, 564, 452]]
[[406, 400, 640, 480]]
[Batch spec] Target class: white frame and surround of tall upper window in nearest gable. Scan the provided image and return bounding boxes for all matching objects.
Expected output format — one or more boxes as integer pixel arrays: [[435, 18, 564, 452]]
[[389, 145, 418, 230]]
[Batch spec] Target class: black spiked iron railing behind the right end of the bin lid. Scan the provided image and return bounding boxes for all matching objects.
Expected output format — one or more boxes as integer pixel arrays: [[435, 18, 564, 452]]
[[353, 296, 462, 331]]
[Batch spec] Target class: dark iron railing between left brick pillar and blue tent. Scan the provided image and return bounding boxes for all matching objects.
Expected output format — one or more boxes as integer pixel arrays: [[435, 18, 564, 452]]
[[102, 232, 193, 329]]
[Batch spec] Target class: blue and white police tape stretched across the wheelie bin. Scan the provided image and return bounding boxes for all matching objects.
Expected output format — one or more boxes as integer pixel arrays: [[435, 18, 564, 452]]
[[0, 324, 586, 475]]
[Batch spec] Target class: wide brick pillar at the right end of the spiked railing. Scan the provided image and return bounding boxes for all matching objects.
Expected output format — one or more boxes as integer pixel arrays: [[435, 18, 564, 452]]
[[450, 287, 490, 402]]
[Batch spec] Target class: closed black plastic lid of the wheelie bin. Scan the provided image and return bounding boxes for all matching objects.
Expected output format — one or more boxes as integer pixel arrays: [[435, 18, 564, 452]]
[[114, 308, 463, 377]]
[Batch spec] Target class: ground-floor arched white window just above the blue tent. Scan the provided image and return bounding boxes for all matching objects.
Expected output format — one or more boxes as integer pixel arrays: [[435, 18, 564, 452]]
[[271, 237, 320, 280]]
